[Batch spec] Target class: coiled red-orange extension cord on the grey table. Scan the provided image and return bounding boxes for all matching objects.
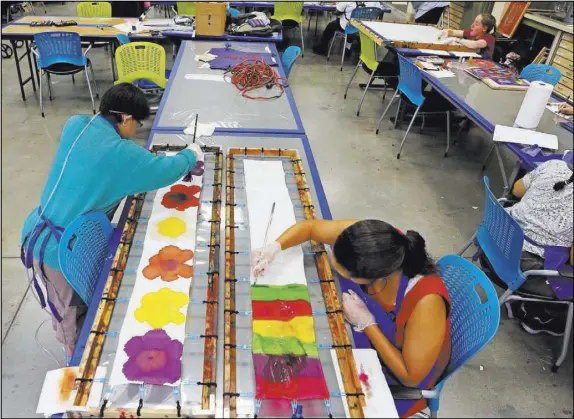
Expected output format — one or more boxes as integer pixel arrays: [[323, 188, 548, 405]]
[[225, 60, 289, 100]]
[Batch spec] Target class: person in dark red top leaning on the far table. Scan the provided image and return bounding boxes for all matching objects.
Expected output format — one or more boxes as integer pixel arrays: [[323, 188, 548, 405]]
[[439, 13, 496, 60]]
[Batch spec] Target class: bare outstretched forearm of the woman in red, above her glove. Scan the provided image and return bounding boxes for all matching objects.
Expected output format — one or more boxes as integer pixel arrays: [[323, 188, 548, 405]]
[[276, 220, 359, 250]]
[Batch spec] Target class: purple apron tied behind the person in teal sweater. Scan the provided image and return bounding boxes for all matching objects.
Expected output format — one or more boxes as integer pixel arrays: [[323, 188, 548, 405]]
[[20, 207, 64, 323]]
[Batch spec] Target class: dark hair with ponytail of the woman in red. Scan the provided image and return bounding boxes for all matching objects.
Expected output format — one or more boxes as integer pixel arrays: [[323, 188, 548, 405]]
[[333, 220, 435, 281]]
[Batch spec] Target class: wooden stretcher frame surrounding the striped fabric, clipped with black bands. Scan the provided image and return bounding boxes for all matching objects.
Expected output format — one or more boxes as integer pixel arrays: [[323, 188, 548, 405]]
[[223, 148, 365, 418]]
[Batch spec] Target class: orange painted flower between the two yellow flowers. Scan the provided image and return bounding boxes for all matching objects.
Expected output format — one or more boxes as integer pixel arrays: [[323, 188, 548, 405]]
[[142, 245, 193, 282]]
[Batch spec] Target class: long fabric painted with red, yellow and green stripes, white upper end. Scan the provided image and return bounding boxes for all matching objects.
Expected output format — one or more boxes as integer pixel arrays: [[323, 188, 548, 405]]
[[244, 160, 330, 401]]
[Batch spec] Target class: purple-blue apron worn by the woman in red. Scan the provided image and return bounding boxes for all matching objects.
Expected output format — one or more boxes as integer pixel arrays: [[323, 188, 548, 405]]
[[339, 275, 452, 417]]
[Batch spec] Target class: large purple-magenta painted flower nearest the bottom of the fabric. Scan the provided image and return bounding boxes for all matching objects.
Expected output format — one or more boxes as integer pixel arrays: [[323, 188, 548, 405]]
[[122, 329, 183, 386]]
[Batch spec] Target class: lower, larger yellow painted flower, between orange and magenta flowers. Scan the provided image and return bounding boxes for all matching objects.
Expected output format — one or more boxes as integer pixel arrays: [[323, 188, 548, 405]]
[[134, 288, 189, 329]]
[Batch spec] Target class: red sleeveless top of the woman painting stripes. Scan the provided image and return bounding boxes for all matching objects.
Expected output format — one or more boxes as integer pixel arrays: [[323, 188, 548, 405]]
[[396, 275, 450, 348]]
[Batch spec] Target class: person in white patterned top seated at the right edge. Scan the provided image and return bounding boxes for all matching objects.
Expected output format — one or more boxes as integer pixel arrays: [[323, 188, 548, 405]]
[[508, 160, 574, 336]]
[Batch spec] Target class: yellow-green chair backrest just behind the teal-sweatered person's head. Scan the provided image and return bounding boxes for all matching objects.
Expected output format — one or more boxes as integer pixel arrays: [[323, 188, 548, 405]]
[[115, 42, 167, 89]]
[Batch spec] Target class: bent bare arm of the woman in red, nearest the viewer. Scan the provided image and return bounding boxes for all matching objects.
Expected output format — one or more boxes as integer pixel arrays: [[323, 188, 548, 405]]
[[364, 294, 446, 387]]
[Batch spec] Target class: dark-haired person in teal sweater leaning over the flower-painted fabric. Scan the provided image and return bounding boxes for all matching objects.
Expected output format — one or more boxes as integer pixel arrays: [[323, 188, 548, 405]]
[[22, 83, 203, 356]]
